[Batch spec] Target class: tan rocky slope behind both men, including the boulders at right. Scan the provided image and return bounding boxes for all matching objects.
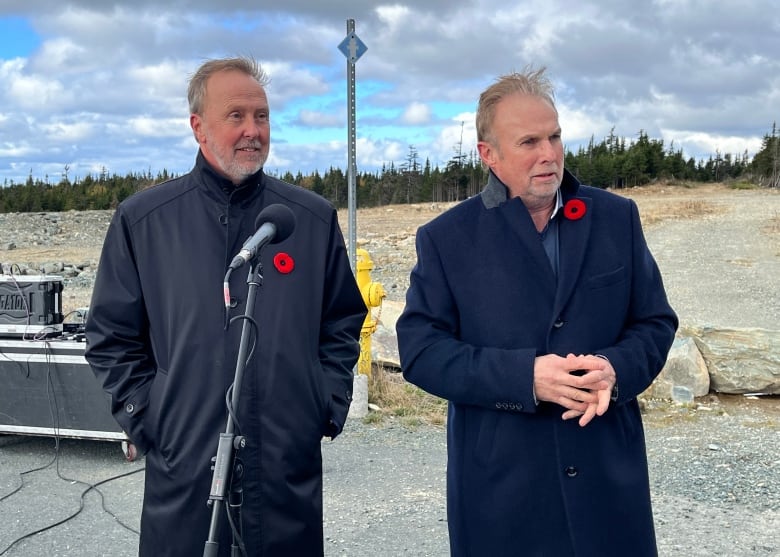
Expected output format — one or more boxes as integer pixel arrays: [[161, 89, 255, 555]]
[[0, 186, 780, 397]]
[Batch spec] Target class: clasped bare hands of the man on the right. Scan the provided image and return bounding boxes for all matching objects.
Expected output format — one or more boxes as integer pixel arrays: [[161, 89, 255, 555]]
[[534, 354, 617, 427]]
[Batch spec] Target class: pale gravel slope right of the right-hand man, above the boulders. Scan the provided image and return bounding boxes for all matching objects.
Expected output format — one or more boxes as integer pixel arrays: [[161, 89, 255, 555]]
[[635, 188, 780, 330]]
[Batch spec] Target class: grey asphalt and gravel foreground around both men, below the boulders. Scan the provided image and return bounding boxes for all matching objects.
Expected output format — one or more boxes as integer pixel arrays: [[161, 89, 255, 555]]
[[0, 404, 780, 557]]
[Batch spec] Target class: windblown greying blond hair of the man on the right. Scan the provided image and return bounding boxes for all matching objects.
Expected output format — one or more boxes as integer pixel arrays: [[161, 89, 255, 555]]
[[476, 66, 557, 141]]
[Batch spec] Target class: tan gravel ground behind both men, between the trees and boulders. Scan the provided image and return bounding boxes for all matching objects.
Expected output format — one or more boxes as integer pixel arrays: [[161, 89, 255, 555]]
[[0, 185, 780, 329]]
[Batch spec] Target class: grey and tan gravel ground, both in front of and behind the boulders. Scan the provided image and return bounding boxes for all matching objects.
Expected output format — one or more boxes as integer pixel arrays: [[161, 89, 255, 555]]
[[0, 182, 780, 557]]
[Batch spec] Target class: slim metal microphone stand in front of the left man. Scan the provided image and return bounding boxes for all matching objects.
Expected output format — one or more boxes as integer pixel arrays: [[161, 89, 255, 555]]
[[203, 257, 263, 557]]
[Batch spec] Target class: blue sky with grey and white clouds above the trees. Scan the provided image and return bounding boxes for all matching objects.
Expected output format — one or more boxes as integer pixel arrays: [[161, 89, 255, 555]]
[[0, 0, 780, 185]]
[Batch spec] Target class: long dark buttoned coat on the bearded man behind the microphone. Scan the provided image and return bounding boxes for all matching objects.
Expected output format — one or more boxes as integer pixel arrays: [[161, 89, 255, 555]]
[[86, 154, 366, 557]]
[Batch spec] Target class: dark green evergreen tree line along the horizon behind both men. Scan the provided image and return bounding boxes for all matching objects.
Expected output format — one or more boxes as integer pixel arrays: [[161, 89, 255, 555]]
[[0, 124, 780, 213]]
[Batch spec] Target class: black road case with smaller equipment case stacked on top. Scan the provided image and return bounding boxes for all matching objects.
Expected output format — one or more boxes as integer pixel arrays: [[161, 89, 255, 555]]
[[0, 275, 136, 460]]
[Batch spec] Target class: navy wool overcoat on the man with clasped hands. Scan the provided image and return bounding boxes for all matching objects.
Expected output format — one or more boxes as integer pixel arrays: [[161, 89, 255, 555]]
[[397, 172, 677, 557]]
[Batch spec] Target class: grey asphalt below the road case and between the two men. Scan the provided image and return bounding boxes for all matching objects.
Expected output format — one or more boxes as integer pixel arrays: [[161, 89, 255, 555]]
[[0, 422, 449, 557]]
